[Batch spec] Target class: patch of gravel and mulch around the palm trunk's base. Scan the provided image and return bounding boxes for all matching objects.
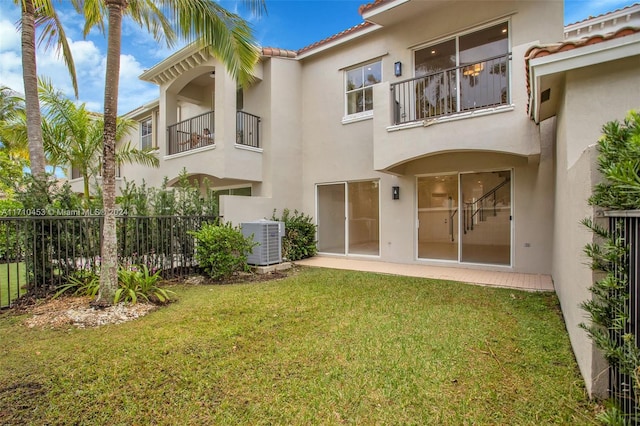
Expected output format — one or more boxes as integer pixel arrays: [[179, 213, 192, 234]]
[[25, 297, 157, 328]]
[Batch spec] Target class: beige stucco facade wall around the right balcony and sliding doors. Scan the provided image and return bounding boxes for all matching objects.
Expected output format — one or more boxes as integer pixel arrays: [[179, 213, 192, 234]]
[[302, 1, 562, 273]]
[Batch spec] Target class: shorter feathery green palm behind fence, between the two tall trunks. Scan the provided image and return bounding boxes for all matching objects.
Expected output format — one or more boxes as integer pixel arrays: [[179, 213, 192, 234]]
[[39, 80, 160, 203]]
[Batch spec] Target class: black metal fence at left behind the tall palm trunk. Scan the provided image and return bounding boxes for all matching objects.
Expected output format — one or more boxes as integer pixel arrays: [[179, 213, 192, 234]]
[[0, 216, 217, 307]]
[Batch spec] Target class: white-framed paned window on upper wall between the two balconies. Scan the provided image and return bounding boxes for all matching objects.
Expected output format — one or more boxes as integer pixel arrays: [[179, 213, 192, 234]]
[[346, 61, 382, 115]]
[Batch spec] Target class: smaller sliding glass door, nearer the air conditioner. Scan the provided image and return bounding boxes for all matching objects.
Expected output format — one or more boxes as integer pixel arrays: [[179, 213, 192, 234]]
[[317, 181, 380, 256]]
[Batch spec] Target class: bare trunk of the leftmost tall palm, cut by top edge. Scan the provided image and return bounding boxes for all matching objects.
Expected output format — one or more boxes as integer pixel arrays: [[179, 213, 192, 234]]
[[21, 0, 46, 180]]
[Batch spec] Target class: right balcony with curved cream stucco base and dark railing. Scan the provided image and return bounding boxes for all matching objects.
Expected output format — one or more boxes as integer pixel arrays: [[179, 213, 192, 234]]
[[373, 49, 540, 175]]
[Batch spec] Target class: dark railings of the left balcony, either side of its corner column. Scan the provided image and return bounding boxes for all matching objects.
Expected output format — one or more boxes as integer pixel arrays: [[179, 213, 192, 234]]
[[167, 111, 260, 155]]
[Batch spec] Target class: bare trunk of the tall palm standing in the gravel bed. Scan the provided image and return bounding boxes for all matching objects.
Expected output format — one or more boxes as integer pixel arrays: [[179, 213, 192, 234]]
[[94, 0, 127, 306]]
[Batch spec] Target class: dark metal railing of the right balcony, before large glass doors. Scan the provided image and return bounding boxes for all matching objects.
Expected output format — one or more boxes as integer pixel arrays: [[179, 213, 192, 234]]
[[391, 53, 511, 124]]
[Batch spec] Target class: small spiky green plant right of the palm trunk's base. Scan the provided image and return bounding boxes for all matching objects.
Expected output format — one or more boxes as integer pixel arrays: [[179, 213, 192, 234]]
[[114, 265, 175, 304]]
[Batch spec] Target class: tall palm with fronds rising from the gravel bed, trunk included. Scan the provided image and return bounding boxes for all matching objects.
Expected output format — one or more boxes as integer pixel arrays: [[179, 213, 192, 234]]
[[74, 0, 265, 306]]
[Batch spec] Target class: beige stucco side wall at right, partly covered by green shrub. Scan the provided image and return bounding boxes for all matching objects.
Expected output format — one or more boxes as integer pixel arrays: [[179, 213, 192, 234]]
[[553, 57, 640, 395]]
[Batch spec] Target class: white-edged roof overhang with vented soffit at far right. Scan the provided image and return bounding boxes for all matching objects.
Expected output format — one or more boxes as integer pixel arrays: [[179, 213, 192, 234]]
[[529, 32, 640, 123]]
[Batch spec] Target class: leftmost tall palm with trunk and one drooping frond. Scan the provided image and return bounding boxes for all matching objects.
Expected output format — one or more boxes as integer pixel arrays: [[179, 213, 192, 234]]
[[14, 0, 78, 180]]
